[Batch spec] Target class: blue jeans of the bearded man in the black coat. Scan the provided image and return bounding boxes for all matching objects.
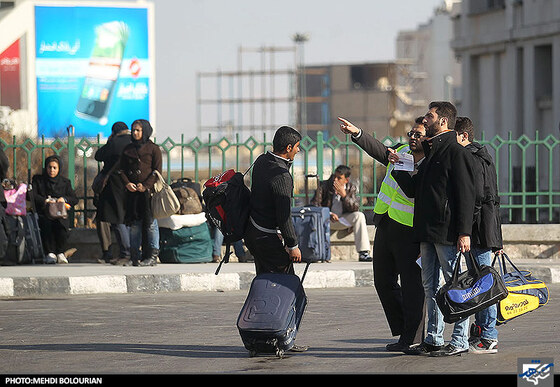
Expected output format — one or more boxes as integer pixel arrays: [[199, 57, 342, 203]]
[[420, 242, 469, 349]]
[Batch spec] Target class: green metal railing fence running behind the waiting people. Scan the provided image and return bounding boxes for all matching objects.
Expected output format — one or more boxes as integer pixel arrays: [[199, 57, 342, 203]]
[[0, 132, 560, 227]]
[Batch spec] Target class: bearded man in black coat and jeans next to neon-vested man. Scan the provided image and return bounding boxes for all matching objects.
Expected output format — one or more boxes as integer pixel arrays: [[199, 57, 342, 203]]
[[392, 101, 475, 356]]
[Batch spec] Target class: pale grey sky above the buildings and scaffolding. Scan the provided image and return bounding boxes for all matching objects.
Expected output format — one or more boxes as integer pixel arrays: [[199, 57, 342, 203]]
[[148, 0, 443, 141]]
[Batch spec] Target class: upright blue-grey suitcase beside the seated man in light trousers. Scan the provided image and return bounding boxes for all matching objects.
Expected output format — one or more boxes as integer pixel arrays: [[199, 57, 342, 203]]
[[292, 206, 331, 262]]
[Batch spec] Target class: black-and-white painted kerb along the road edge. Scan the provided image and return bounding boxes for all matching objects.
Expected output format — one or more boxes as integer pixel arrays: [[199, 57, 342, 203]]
[[0, 262, 560, 298]]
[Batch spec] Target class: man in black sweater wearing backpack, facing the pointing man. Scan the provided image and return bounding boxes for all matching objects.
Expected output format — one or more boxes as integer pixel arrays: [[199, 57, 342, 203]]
[[244, 126, 301, 275]]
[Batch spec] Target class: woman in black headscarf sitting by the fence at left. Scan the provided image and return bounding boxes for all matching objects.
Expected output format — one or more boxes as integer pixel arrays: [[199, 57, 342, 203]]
[[32, 155, 78, 263]]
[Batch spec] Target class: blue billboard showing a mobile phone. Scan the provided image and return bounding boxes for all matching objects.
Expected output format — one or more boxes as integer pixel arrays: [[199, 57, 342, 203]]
[[35, 6, 151, 138]]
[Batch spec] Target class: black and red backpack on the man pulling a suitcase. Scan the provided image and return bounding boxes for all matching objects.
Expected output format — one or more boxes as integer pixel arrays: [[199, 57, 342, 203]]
[[202, 168, 251, 274]]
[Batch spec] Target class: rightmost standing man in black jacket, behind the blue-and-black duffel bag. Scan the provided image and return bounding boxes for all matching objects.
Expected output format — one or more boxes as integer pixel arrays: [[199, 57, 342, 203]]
[[455, 117, 503, 353]]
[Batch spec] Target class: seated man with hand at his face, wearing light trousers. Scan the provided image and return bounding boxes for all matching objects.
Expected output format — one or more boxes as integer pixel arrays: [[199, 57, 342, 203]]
[[311, 165, 373, 262]]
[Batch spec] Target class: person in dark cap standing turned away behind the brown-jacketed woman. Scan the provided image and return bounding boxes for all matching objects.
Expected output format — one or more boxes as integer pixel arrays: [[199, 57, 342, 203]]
[[94, 121, 131, 263]]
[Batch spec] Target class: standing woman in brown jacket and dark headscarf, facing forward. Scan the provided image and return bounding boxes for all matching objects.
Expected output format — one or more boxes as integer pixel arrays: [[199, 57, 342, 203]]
[[117, 119, 162, 266]]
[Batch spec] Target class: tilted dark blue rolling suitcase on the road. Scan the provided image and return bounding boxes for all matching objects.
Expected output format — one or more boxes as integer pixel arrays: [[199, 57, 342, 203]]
[[237, 262, 310, 358]]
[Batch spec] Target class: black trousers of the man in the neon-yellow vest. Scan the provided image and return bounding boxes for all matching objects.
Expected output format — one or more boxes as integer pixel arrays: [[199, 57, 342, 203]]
[[373, 216, 425, 344]]
